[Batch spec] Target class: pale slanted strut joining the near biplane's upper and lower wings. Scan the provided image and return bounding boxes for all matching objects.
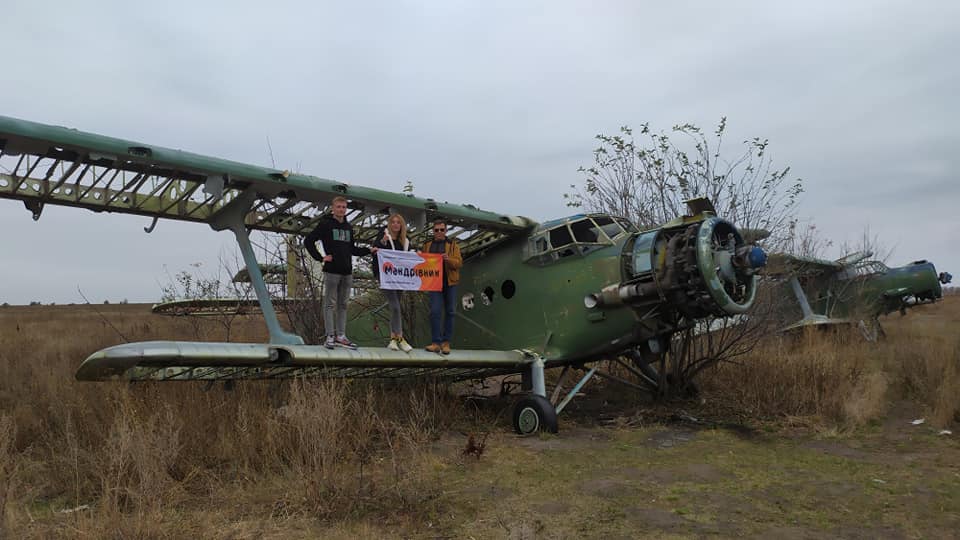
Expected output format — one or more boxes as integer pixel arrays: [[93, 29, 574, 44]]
[[210, 188, 303, 345]]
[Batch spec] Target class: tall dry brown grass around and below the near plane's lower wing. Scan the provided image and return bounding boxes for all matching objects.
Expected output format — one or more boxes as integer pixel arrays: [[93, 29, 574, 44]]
[[0, 306, 462, 538]]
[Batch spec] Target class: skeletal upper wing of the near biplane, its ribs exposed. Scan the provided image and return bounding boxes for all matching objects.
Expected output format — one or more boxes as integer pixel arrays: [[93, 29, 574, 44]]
[[0, 116, 535, 256]]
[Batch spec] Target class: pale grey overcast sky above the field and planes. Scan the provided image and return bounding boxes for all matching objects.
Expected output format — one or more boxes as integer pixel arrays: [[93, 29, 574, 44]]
[[0, 0, 960, 303]]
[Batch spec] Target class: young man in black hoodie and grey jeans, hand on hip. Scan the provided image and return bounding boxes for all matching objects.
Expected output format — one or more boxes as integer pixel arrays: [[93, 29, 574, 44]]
[[304, 197, 377, 349]]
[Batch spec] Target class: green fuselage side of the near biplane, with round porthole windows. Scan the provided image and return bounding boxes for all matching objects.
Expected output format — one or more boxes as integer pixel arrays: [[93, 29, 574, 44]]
[[350, 235, 637, 363]]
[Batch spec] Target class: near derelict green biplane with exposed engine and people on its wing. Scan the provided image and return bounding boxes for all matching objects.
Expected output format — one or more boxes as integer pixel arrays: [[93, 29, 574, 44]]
[[0, 117, 766, 434]]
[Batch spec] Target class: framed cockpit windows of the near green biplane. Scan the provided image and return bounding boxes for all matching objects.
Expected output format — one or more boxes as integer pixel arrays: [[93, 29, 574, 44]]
[[524, 214, 637, 264]]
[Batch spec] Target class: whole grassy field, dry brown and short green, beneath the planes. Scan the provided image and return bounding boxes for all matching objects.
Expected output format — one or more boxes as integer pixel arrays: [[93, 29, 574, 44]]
[[0, 296, 960, 539]]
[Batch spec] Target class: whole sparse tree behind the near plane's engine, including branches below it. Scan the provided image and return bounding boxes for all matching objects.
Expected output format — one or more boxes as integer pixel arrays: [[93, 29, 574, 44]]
[[564, 118, 804, 398]]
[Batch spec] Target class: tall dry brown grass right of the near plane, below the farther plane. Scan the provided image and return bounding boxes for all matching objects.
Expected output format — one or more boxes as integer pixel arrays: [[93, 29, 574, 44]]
[[703, 297, 960, 426]]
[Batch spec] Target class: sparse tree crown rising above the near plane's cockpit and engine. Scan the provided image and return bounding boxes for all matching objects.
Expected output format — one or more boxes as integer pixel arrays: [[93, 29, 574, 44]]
[[564, 118, 803, 249]]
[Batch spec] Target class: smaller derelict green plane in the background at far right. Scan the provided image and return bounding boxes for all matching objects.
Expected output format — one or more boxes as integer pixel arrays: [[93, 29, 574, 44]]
[[763, 251, 953, 341]]
